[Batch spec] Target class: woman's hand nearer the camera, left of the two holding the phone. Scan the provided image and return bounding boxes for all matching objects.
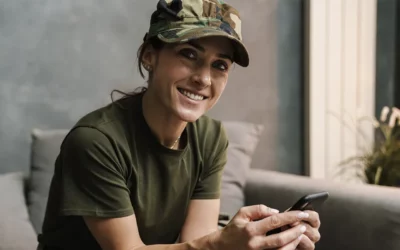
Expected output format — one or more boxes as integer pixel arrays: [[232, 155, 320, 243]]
[[213, 205, 307, 250]]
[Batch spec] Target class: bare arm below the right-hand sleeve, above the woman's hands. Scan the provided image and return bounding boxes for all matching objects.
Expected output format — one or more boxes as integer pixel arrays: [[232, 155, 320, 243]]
[[179, 199, 220, 242]]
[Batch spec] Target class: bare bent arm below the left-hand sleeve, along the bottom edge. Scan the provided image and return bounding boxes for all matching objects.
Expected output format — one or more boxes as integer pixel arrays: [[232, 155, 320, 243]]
[[84, 215, 214, 250]]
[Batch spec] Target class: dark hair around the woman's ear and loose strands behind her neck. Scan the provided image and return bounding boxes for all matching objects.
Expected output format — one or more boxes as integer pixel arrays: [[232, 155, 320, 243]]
[[111, 37, 165, 102]]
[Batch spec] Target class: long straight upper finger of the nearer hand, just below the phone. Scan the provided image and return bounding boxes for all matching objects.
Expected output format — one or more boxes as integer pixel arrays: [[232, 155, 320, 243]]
[[255, 211, 309, 232]]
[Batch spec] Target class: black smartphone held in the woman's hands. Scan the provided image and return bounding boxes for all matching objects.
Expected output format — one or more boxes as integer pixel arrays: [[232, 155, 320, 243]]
[[267, 191, 329, 235]]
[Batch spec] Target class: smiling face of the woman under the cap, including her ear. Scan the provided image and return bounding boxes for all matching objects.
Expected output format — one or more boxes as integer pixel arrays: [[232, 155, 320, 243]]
[[143, 37, 233, 122]]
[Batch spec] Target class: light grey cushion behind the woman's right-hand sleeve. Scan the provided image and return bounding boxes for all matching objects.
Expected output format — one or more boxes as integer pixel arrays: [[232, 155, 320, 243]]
[[221, 121, 264, 218]]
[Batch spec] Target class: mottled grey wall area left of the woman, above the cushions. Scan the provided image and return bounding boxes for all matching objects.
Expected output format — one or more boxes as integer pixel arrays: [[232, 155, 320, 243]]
[[0, 0, 154, 174]]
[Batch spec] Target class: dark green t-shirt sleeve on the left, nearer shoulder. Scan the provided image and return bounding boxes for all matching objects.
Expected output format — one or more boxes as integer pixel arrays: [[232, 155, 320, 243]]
[[58, 127, 133, 218]]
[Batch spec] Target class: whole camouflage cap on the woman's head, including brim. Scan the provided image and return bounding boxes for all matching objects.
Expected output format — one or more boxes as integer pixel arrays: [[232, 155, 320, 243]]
[[144, 0, 249, 67]]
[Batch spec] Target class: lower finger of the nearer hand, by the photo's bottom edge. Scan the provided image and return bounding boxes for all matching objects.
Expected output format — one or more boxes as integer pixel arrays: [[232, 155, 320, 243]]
[[261, 225, 306, 249]]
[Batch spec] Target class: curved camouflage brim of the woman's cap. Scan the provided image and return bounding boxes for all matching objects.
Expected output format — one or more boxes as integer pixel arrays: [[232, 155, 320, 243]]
[[157, 27, 250, 67]]
